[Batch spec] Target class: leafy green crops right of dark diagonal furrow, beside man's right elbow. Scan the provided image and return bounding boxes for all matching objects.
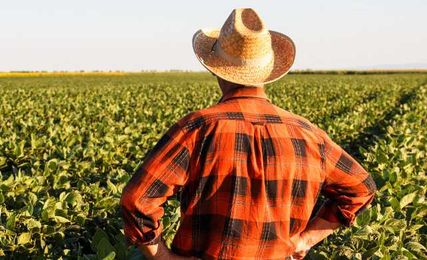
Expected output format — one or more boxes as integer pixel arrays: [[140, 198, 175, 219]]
[[310, 85, 427, 259]]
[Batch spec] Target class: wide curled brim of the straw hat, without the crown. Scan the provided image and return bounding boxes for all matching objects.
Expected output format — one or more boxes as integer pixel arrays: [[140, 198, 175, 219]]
[[193, 29, 295, 85]]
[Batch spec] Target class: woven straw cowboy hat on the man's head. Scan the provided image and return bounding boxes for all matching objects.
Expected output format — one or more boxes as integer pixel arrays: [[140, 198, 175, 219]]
[[193, 8, 295, 85]]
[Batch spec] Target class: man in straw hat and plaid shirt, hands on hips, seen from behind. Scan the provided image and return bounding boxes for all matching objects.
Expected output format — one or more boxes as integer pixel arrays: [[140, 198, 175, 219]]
[[121, 9, 376, 259]]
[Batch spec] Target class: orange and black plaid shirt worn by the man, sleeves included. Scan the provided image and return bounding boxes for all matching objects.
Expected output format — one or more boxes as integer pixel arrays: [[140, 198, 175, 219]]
[[121, 87, 376, 259]]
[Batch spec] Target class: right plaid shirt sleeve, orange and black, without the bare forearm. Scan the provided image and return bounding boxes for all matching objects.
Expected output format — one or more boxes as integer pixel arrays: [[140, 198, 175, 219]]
[[318, 130, 377, 227]]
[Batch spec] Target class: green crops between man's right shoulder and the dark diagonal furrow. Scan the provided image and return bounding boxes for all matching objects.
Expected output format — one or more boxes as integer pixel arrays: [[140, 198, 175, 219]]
[[267, 75, 425, 128]]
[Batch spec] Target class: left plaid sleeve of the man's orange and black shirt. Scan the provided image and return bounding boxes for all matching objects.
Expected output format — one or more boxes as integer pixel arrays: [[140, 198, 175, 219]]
[[120, 123, 191, 246]]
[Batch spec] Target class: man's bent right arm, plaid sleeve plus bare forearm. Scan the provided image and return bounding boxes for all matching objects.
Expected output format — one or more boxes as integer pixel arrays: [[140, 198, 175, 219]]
[[294, 129, 377, 259]]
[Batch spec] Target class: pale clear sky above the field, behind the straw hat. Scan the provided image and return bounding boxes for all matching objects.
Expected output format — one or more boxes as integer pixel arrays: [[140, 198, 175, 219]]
[[0, 0, 427, 71]]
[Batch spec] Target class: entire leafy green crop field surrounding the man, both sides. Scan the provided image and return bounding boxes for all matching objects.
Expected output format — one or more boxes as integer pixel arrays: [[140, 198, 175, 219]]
[[0, 73, 427, 259]]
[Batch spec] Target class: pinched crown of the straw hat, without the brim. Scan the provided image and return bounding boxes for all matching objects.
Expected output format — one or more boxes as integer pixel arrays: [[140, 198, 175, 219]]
[[216, 8, 272, 60]]
